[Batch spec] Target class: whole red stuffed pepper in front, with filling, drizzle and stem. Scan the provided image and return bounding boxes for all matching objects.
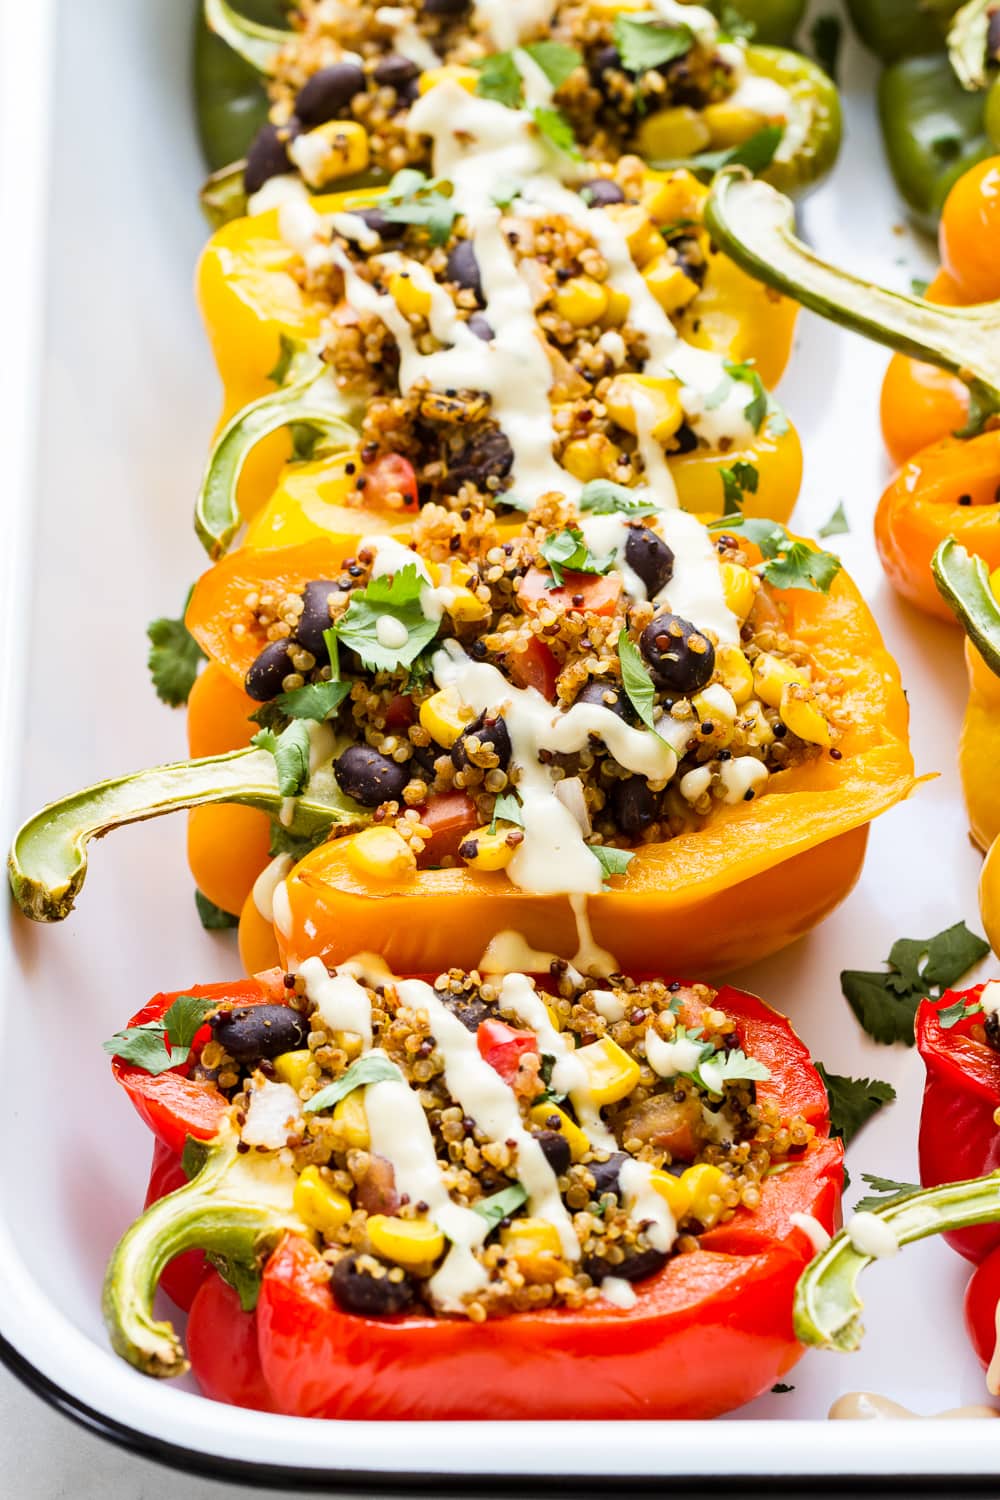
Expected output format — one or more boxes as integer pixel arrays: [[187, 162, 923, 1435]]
[[105, 960, 843, 1419]]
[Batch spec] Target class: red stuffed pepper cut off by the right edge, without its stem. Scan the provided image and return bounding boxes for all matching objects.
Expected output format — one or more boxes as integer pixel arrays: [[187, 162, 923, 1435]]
[[916, 984, 1000, 1262]]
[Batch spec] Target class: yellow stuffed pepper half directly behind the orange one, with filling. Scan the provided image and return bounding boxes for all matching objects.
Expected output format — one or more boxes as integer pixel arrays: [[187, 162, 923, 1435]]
[[196, 141, 802, 557]]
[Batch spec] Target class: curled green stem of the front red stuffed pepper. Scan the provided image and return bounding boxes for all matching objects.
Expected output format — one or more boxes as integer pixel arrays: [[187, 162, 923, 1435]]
[[103, 1124, 301, 1379]]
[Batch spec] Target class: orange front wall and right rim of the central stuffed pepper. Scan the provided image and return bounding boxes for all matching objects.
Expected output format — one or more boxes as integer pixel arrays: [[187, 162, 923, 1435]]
[[275, 549, 913, 974]]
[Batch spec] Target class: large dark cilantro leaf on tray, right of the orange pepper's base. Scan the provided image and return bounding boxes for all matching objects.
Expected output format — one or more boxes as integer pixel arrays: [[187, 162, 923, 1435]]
[[840, 923, 990, 1047]]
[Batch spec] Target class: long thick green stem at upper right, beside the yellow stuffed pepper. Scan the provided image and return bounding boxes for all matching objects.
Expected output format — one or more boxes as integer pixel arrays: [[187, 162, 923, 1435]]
[[705, 168, 1000, 431]]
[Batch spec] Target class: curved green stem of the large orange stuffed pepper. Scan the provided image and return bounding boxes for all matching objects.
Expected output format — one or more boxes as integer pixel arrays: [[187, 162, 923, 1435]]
[[7, 749, 367, 923]]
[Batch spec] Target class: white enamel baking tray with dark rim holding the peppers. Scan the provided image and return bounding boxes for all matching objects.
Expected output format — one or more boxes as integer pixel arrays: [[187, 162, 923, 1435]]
[[0, 0, 997, 1493]]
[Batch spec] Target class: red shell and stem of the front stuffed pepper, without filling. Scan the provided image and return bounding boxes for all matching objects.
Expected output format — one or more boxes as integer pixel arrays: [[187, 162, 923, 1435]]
[[105, 989, 843, 1421]]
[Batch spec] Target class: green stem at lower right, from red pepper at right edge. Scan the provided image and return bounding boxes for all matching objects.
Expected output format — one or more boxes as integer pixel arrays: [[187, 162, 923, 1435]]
[[795, 1172, 1000, 1350]]
